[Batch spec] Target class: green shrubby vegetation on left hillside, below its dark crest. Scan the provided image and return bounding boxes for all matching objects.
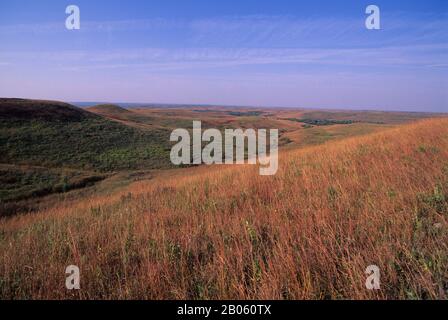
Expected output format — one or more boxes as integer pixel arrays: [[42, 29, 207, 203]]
[[0, 119, 169, 172]]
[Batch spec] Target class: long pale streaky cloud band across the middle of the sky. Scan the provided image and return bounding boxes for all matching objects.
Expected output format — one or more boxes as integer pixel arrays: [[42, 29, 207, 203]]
[[0, 44, 448, 71]]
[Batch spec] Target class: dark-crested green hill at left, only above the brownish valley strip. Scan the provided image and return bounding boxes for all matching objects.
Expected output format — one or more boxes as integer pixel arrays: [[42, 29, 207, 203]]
[[0, 98, 170, 172]]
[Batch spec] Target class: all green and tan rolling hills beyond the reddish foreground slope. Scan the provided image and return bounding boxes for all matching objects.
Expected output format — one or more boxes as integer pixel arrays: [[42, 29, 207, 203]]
[[0, 98, 436, 215]]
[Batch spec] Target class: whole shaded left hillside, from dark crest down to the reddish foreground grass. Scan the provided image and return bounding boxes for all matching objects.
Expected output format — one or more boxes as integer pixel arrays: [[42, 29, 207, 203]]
[[0, 98, 171, 216]]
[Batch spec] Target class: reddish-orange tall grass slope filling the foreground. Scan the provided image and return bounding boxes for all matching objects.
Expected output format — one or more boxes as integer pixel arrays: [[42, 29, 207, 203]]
[[0, 119, 448, 299]]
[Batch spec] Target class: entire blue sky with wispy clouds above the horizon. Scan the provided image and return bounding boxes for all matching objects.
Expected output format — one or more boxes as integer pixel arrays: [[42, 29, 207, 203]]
[[0, 0, 448, 112]]
